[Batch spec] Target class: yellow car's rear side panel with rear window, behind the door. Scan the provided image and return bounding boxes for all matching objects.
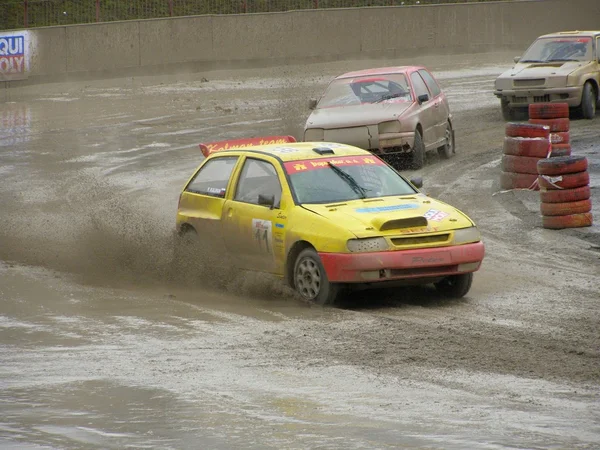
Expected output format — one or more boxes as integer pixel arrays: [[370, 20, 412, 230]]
[[178, 156, 239, 254]]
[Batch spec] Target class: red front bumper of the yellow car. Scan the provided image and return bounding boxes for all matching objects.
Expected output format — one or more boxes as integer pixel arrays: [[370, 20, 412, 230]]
[[319, 242, 485, 283]]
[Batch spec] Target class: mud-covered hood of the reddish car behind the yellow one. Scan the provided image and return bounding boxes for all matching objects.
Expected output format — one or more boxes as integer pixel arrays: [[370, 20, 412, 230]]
[[306, 101, 413, 129]]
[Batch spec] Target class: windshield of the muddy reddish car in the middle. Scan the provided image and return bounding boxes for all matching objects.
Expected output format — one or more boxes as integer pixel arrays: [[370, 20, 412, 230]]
[[317, 73, 413, 109]]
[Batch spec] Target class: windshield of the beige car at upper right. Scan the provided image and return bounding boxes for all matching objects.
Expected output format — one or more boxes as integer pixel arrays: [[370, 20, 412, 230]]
[[520, 37, 592, 62]]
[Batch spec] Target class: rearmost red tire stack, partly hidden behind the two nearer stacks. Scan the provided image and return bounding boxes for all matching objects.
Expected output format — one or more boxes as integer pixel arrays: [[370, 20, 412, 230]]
[[529, 103, 571, 157]]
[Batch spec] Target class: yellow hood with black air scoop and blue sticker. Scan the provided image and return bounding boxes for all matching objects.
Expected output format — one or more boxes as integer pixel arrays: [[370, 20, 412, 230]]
[[302, 194, 473, 237]]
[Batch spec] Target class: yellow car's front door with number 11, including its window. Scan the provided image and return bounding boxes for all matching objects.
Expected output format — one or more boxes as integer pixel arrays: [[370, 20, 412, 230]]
[[223, 154, 292, 274]]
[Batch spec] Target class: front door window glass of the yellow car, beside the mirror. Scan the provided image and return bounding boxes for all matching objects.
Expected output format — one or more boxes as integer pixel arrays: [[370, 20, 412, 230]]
[[234, 158, 281, 207]]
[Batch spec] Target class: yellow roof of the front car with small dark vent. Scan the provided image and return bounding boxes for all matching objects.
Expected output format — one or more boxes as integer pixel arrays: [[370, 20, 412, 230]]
[[210, 142, 372, 162]]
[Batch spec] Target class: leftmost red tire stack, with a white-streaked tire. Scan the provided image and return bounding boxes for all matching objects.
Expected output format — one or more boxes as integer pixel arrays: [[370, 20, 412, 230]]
[[500, 123, 550, 190]]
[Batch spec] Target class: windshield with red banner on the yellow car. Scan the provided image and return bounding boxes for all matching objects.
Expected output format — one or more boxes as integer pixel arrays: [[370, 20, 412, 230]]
[[284, 156, 416, 204]]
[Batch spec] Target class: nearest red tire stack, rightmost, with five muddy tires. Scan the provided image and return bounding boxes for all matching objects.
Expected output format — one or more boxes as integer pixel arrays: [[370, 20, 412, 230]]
[[537, 156, 592, 230]]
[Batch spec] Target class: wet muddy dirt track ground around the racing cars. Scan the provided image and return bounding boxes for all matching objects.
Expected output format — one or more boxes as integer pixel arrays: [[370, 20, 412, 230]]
[[0, 53, 600, 449]]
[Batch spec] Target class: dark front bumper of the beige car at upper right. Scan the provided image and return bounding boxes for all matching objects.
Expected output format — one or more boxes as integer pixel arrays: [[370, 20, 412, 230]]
[[494, 86, 582, 108]]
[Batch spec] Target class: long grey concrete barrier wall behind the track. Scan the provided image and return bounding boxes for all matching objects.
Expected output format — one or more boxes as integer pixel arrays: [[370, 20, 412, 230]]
[[4, 0, 600, 87]]
